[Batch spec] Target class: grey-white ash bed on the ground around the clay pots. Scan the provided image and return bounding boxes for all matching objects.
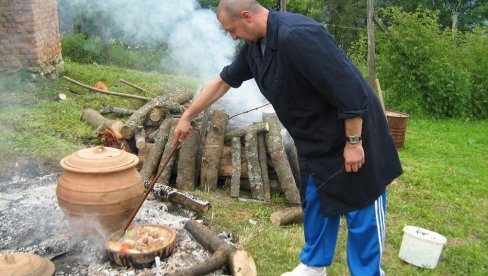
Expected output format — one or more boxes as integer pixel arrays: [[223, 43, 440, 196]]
[[0, 173, 224, 276]]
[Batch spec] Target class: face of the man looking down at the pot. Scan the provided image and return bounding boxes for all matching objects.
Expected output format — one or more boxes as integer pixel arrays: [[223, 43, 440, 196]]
[[219, 13, 259, 44]]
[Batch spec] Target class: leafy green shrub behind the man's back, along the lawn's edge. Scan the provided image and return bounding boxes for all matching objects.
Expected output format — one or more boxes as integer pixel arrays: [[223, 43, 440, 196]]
[[350, 7, 488, 119]]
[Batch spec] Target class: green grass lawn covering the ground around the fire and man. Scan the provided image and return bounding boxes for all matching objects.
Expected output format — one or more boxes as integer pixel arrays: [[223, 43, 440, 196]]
[[0, 62, 488, 275]]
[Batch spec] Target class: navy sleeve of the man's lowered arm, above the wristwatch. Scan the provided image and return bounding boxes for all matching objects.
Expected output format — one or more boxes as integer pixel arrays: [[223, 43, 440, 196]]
[[280, 25, 369, 119]]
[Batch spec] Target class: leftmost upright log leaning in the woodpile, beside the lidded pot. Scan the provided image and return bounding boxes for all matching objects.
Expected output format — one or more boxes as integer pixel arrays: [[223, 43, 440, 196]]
[[140, 118, 171, 180]]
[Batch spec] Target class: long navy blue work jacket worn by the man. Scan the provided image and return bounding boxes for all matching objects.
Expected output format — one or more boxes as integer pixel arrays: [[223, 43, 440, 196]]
[[220, 11, 402, 215]]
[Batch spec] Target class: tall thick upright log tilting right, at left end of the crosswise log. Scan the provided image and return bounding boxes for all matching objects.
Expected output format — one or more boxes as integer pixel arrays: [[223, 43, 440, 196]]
[[200, 110, 229, 191]]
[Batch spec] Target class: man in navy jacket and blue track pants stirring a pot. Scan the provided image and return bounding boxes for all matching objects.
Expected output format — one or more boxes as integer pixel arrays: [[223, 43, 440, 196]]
[[174, 0, 402, 276]]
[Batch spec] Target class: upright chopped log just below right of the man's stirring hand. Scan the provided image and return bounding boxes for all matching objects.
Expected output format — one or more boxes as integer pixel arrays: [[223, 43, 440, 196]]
[[175, 130, 198, 191]]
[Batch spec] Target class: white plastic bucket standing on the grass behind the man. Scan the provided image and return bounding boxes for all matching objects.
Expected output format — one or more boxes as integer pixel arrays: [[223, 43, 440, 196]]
[[399, 225, 447, 268]]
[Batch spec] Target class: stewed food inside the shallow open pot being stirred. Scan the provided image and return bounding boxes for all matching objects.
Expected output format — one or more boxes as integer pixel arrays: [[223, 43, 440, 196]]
[[107, 225, 169, 254]]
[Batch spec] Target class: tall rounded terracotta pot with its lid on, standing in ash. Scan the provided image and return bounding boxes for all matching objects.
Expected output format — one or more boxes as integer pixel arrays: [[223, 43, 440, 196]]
[[56, 146, 144, 237]]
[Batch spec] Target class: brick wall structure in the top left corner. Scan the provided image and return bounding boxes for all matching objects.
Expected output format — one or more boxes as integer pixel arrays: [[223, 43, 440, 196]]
[[0, 0, 64, 75]]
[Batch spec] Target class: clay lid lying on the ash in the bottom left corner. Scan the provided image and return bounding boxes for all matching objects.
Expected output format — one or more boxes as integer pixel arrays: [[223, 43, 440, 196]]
[[0, 252, 54, 276]]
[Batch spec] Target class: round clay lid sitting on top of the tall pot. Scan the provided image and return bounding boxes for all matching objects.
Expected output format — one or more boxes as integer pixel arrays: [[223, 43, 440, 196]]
[[60, 146, 139, 173]]
